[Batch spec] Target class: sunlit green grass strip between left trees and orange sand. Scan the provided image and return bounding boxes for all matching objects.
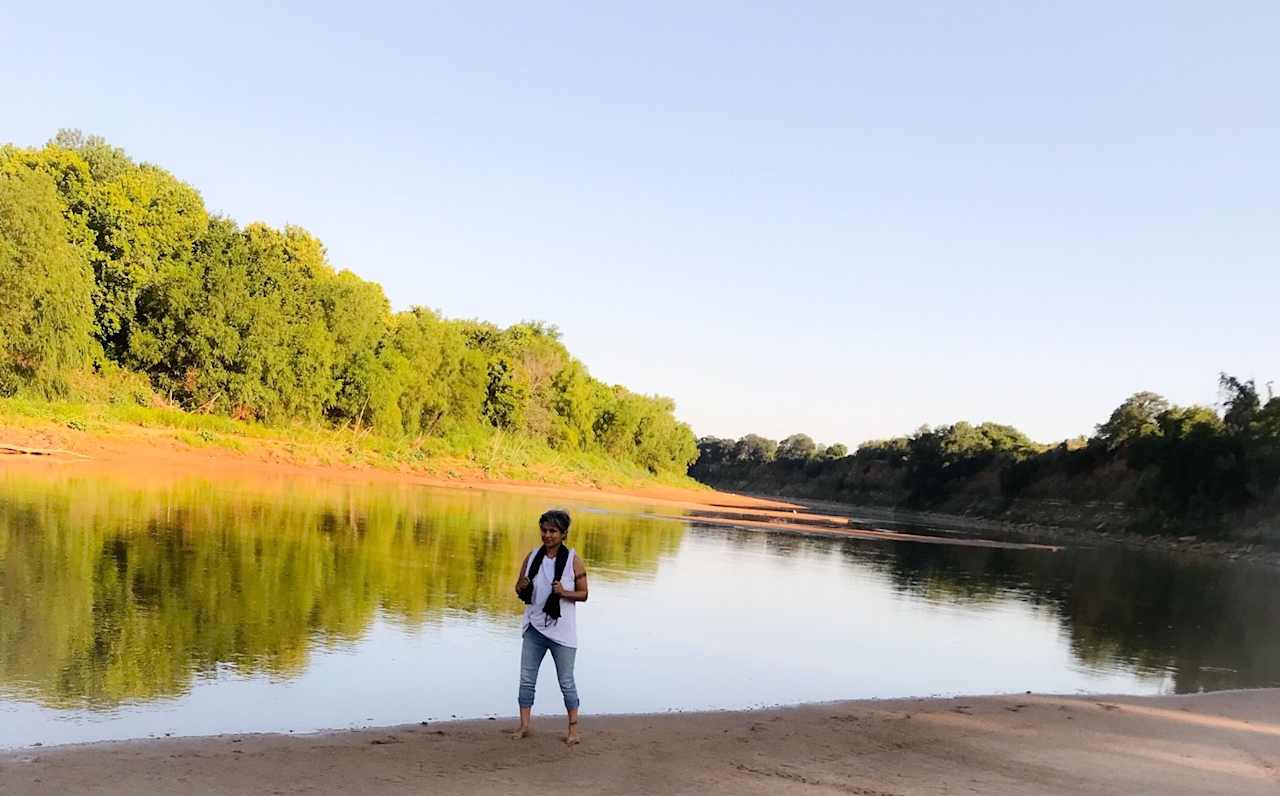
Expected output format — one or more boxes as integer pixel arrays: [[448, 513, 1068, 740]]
[[0, 397, 707, 489]]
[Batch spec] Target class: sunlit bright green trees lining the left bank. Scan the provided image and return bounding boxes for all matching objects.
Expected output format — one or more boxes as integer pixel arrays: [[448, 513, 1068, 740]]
[[0, 131, 698, 472]]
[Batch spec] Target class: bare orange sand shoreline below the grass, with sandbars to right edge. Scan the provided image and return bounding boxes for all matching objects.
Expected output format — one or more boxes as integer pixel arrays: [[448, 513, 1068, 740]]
[[0, 422, 1280, 567]]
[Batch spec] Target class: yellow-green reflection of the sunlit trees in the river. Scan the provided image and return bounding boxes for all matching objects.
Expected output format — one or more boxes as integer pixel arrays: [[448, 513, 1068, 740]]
[[0, 474, 684, 708]]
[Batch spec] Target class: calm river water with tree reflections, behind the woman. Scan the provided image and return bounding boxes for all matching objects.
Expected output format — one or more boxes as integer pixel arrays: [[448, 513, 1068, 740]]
[[0, 468, 1280, 747]]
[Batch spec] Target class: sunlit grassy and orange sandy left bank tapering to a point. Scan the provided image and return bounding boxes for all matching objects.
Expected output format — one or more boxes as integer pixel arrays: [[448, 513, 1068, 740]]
[[0, 399, 792, 509]]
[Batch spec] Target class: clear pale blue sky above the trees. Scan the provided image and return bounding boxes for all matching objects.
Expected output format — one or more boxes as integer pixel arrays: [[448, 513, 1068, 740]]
[[0, 0, 1280, 444]]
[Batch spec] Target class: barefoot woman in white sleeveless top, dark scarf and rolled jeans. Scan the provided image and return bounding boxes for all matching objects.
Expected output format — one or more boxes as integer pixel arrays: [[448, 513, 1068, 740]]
[[513, 509, 586, 746]]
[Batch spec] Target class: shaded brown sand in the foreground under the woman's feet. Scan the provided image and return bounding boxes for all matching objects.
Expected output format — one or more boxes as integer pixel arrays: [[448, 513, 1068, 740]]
[[0, 689, 1280, 796]]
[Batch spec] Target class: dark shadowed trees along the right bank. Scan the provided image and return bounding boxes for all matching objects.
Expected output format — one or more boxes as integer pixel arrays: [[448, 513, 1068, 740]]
[[689, 374, 1280, 532]]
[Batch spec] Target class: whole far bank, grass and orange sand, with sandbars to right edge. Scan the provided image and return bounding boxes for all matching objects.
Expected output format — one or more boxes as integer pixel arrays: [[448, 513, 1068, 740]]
[[10, 399, 1280, 566]]
